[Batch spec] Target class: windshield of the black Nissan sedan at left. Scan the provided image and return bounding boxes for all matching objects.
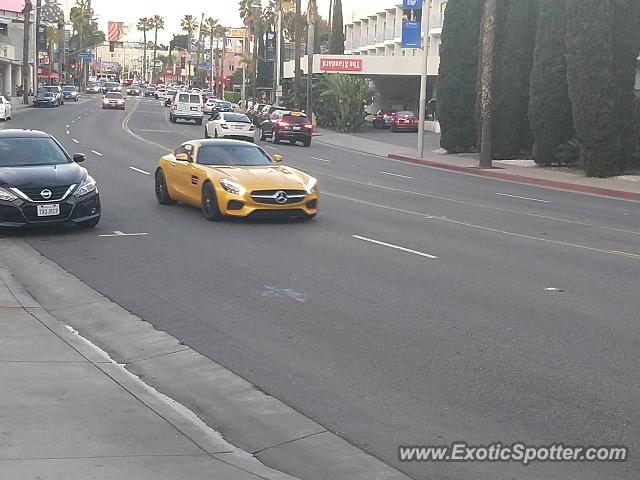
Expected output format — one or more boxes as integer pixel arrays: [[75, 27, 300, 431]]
[[0, 137, 71, 167]]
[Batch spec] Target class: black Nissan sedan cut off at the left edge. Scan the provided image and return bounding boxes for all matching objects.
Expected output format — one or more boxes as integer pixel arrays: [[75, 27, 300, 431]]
[[0, 130, 100, 227]]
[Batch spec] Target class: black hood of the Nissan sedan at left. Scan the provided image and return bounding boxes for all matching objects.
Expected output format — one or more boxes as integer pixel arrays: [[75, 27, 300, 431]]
[[0, 163, 86, 187]]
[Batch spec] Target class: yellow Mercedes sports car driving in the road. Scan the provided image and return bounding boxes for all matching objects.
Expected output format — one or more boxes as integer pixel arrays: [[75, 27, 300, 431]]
[[155, 139, 318, 221]]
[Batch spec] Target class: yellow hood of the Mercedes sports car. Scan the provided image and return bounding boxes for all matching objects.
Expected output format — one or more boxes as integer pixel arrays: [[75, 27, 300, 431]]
[[206, 166, 311, 191]]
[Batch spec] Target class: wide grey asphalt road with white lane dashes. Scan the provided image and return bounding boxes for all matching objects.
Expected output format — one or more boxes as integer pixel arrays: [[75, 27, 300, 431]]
[[3, 94, 640, 480]]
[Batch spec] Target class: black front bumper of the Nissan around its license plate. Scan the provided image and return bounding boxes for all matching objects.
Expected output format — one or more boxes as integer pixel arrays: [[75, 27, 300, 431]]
[[0, 192, 101, 228]]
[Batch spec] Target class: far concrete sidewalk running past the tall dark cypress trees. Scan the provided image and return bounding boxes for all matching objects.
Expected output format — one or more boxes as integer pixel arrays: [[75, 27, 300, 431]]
[[314, 129, 640, 201]]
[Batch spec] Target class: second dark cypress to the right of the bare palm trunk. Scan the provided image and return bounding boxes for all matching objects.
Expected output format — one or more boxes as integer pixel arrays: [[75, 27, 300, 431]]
[[529, 0, 575, 166]]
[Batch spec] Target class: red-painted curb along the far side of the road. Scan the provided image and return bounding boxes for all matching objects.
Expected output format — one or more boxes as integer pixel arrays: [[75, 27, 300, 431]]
[[388, 153, 640, 201]]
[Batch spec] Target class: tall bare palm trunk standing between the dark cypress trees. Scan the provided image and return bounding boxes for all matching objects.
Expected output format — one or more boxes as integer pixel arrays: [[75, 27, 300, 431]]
[[479, 0, 496, 168]]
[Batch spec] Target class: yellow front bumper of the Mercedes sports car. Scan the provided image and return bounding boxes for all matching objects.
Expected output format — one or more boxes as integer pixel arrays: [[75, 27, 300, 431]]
[[217, 190, 319, 218]]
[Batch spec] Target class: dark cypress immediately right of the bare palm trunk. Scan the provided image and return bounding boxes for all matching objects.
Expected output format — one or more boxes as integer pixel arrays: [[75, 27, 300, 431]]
[[492, 0, 538, 158]]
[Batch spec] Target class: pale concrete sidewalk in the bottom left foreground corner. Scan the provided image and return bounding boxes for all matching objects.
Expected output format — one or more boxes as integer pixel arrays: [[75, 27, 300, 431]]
[[0, 264, 295, 480]]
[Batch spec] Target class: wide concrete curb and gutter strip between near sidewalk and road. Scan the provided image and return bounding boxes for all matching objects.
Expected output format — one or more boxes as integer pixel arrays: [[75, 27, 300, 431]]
[[0, 239, 409, 480]]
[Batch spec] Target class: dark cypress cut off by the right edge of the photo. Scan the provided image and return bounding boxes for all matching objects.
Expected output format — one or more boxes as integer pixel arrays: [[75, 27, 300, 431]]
[[610, 0, 640, 168]]
